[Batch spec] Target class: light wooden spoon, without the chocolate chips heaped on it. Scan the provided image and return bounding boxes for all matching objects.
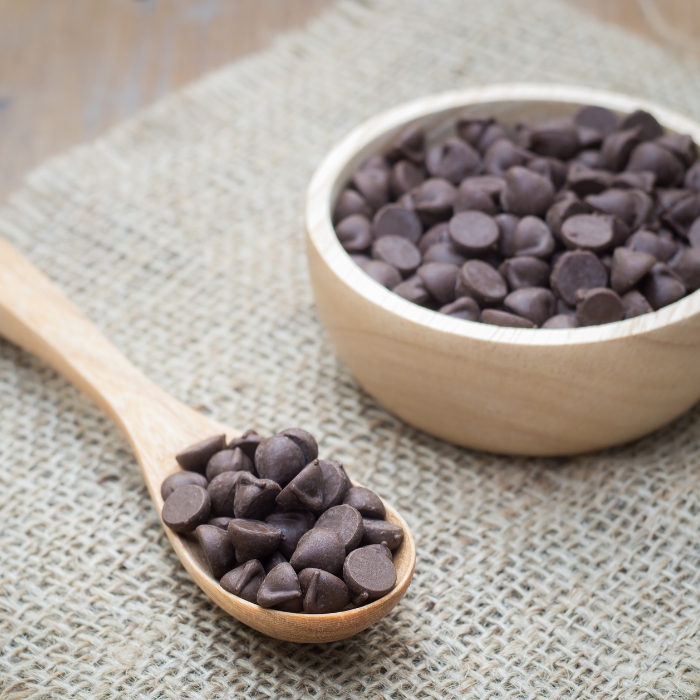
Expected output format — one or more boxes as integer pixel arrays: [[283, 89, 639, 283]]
[[0, 239, 416, 642]]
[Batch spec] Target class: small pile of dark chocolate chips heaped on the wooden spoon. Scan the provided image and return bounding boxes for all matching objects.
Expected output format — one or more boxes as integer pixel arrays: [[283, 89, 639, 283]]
[[161, 428, 403, 614]]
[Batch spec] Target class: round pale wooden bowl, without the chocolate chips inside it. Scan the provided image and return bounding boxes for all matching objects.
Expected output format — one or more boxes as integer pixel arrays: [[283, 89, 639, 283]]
[[306, 84, 700, 455]]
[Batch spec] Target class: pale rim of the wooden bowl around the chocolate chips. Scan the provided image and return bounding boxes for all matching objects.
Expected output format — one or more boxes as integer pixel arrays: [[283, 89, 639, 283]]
[[305, 83, 700, 346]]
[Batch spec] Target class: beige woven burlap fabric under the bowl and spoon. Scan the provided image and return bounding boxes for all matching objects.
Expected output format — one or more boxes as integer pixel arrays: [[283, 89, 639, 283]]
[[0, 0, 700, 700]]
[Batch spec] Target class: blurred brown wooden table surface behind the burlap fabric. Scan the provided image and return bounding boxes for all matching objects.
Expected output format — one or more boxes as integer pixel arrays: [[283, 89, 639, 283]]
[[0, 0, 700, 202]]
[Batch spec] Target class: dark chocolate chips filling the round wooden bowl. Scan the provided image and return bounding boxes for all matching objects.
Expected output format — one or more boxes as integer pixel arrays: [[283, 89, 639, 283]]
[[334, 106, 700, 328]]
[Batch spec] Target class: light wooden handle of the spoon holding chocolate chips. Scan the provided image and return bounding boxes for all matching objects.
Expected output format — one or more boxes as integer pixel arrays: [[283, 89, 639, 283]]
[[0, 238, 221, 494]]
